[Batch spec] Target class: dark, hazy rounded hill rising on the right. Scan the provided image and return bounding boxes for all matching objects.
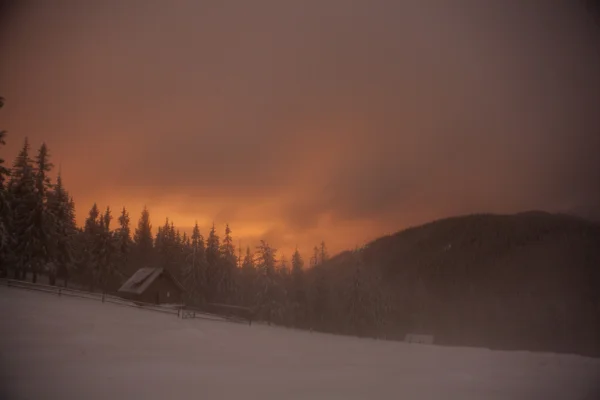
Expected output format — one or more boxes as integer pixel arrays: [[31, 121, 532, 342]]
[[311, 211, 600, 356]]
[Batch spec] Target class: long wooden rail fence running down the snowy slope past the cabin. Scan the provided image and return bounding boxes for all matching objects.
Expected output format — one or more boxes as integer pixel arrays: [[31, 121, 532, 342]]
[[0, 278, 252, 325]]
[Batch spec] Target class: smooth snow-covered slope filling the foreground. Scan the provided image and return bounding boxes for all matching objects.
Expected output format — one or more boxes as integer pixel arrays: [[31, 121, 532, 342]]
[[0, 287, 600, 400]]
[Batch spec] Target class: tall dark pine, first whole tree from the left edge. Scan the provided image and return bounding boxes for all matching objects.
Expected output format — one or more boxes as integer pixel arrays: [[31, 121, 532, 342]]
[[8, 138, 37, 279]]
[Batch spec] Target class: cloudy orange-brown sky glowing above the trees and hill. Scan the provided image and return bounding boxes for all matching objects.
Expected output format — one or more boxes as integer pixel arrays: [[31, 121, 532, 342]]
[[0, 0, 600, 258]]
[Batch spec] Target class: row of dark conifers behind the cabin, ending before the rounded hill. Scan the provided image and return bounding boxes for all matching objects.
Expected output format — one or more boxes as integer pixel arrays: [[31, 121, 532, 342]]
[[0, 129, 390, 333]]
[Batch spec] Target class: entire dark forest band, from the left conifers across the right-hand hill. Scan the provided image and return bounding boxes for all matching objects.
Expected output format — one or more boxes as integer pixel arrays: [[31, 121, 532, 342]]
[[0, 97, 600, 355]]
